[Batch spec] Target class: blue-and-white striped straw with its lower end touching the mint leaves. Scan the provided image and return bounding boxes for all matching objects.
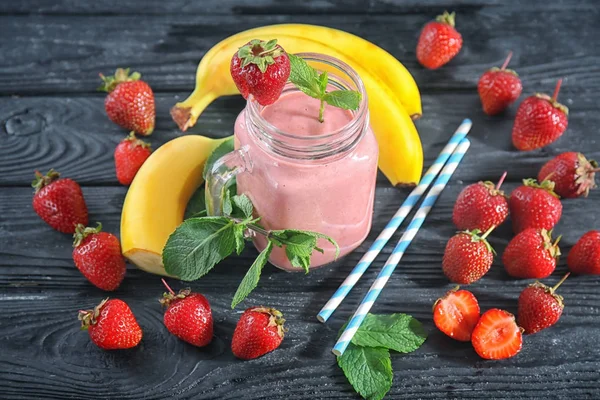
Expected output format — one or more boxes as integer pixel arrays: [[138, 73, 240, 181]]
[[333, 139, 471, 356]]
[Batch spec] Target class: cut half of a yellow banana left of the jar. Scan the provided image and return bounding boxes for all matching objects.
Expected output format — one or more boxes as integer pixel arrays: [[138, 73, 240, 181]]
[[121, 135, 226, 275]]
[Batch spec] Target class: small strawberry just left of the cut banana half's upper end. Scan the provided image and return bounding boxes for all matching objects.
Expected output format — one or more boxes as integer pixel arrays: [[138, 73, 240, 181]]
[[115, 131, 152, 185]]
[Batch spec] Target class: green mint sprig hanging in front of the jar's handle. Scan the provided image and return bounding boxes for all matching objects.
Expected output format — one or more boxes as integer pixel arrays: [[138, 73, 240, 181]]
[[162, 194, 339, 308]]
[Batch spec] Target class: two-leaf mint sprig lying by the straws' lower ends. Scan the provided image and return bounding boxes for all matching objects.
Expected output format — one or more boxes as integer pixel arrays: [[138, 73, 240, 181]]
[[337, 314, 427, 400]]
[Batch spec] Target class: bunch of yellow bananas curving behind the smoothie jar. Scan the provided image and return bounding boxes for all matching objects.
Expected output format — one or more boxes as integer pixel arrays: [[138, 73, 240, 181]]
[[171, 24, 423, 185]]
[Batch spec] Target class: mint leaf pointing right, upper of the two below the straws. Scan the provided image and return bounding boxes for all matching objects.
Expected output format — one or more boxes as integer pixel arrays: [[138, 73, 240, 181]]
[[352, 314, 427, 353]]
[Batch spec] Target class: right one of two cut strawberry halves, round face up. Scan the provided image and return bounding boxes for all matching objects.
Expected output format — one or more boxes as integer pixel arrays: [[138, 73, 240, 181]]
[[471, 308, 523, 360]]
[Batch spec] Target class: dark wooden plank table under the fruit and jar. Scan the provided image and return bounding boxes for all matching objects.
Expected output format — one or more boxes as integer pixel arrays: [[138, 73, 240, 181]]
[[0, 0, 600, 399]]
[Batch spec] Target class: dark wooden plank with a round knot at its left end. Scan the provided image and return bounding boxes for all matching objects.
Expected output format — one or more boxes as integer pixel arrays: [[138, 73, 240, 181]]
[[0, 92, 600, 186]]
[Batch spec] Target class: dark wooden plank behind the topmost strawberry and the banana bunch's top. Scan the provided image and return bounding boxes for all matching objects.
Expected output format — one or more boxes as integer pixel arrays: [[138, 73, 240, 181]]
[[0, 9, 600, 95]]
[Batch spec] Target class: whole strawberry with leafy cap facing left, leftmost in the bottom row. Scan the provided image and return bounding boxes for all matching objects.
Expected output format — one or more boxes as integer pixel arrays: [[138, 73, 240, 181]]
[[78, 299, 142, 350]]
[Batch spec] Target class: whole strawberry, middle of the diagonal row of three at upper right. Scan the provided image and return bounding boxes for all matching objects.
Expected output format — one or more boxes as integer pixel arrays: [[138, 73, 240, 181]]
[[477, 52, 523, 115]]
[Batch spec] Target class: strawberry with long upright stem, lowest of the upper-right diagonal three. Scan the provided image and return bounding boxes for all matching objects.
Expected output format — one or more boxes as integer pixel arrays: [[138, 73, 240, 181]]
[[512, 79, 569, 150]]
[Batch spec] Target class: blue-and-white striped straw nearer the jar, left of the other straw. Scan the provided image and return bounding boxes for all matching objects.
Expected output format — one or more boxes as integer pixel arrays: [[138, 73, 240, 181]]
[[317, 119, 473, 322]]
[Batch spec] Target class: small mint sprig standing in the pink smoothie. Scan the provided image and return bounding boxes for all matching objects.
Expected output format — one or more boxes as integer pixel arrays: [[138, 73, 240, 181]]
[[288, 54, 362, 122]]
